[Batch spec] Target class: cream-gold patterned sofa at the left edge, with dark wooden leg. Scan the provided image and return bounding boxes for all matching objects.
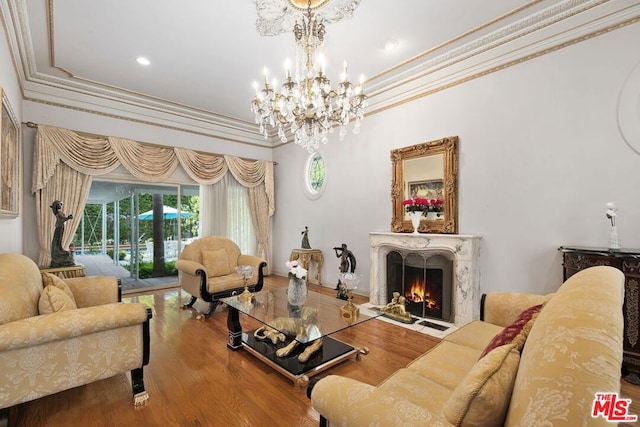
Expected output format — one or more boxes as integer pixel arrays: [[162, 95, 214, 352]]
[[0, 253, 151, 424]]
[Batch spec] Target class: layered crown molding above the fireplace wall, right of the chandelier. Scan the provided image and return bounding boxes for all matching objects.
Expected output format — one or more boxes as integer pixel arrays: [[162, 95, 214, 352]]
[[365, 0, 640, 115]]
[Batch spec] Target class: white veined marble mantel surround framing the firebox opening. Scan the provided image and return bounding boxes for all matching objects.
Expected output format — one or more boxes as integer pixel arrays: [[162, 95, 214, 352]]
[[369, 232, 481, 326]]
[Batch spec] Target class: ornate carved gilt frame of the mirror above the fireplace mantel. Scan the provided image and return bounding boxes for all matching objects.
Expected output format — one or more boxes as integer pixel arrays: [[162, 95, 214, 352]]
[[391, 136, 458, 234]]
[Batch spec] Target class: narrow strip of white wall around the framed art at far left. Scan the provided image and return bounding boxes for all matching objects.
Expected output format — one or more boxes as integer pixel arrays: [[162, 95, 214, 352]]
[[0, 14, 26, 253]]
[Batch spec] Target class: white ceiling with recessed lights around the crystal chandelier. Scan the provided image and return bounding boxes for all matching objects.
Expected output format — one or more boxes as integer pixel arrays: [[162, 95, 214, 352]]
[[5, 0, 637, 148]]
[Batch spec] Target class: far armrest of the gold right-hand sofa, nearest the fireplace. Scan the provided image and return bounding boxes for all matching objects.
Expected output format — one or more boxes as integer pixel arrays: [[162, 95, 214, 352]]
[[480, 292, 553, 326]]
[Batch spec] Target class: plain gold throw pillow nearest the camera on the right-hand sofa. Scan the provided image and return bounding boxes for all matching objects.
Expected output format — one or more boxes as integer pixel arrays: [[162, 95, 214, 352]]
[[442, 344, 520, 427]]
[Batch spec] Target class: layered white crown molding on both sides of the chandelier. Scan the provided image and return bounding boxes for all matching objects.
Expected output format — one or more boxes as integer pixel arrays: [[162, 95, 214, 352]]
[[0, 0, 640, 148]]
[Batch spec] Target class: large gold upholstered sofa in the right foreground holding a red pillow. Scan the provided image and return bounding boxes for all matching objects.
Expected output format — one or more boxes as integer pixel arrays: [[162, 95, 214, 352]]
[[309, 267, 624, 427]]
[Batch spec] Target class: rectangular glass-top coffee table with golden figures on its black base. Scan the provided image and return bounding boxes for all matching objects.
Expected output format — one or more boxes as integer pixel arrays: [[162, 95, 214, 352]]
[[222, 287, 377, 387]]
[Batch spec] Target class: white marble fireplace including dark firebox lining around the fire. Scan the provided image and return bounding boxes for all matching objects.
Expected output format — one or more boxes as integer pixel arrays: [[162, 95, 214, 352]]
[[369, 232, 481, 327]]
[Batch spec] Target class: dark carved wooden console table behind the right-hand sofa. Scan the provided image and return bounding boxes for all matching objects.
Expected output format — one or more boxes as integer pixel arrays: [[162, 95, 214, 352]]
[[559, 246, 640, 385]]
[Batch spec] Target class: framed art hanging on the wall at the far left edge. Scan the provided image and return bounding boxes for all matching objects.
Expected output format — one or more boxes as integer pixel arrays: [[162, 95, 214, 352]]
[[0, 88, 22, 216]]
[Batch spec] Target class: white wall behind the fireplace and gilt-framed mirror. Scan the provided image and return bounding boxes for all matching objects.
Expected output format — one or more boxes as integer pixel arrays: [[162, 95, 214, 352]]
[[273, 23, 640, 295]]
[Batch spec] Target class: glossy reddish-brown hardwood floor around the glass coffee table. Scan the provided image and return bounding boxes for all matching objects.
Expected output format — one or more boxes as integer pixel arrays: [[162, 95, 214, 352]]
[[11, 276, 640, 427]]
